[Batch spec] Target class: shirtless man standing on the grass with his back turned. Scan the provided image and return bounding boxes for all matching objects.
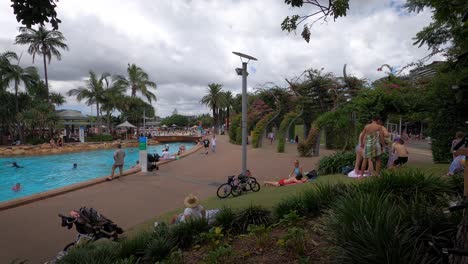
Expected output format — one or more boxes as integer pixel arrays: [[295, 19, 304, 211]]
[[360, 117, 384, 177]]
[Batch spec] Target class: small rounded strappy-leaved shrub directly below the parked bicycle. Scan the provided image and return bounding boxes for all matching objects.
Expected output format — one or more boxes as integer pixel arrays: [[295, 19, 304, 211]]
[[234, 205, 273, 233]]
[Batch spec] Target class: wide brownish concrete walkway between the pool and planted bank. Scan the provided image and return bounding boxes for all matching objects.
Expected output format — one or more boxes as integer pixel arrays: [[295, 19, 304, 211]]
[[0, 136, 330, 263]]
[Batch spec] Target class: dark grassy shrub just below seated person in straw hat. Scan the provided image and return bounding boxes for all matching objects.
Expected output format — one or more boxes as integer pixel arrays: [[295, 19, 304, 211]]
[[169, 219, 210, 249]]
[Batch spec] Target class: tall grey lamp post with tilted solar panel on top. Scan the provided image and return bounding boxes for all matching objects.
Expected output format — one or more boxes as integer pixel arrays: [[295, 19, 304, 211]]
[[232, 51, 257, 175]]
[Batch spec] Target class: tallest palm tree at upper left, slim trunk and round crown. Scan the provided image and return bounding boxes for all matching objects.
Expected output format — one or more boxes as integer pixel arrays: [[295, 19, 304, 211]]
[[15, 26, 68, 98]]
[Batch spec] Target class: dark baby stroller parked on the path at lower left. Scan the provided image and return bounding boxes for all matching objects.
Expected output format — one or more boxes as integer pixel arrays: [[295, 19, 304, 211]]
[[59, 207, 123, 251]]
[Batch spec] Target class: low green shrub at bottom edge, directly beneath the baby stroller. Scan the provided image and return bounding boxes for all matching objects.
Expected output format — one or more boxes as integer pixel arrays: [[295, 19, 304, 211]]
[[57, 241, 119, 264]]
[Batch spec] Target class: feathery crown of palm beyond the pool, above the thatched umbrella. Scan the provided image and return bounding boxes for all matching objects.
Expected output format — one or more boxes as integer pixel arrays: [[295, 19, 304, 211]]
[[116, 64, 156, 103]]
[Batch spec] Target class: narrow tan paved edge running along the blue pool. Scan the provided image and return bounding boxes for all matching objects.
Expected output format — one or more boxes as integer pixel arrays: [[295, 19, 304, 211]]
[[0, 145, 203, 211]]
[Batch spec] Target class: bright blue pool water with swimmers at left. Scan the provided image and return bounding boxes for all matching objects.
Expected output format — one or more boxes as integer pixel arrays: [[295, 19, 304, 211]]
[[0, 143, 194, 202]]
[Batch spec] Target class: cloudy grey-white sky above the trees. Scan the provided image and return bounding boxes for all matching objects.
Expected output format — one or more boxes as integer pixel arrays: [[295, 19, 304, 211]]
[[0, 0, 440, 117]]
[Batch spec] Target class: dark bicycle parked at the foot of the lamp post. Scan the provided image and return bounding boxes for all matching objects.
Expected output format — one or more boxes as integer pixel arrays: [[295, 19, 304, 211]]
[[216, 175, 260, 199]]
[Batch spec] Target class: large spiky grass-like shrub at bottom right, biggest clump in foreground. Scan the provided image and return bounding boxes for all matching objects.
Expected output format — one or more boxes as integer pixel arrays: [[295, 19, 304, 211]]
[[327, 191, 419, 264]]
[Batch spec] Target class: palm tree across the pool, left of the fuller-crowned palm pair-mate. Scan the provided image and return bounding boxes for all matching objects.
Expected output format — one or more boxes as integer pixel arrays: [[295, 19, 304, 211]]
[[68, 71, 106, 133]]
